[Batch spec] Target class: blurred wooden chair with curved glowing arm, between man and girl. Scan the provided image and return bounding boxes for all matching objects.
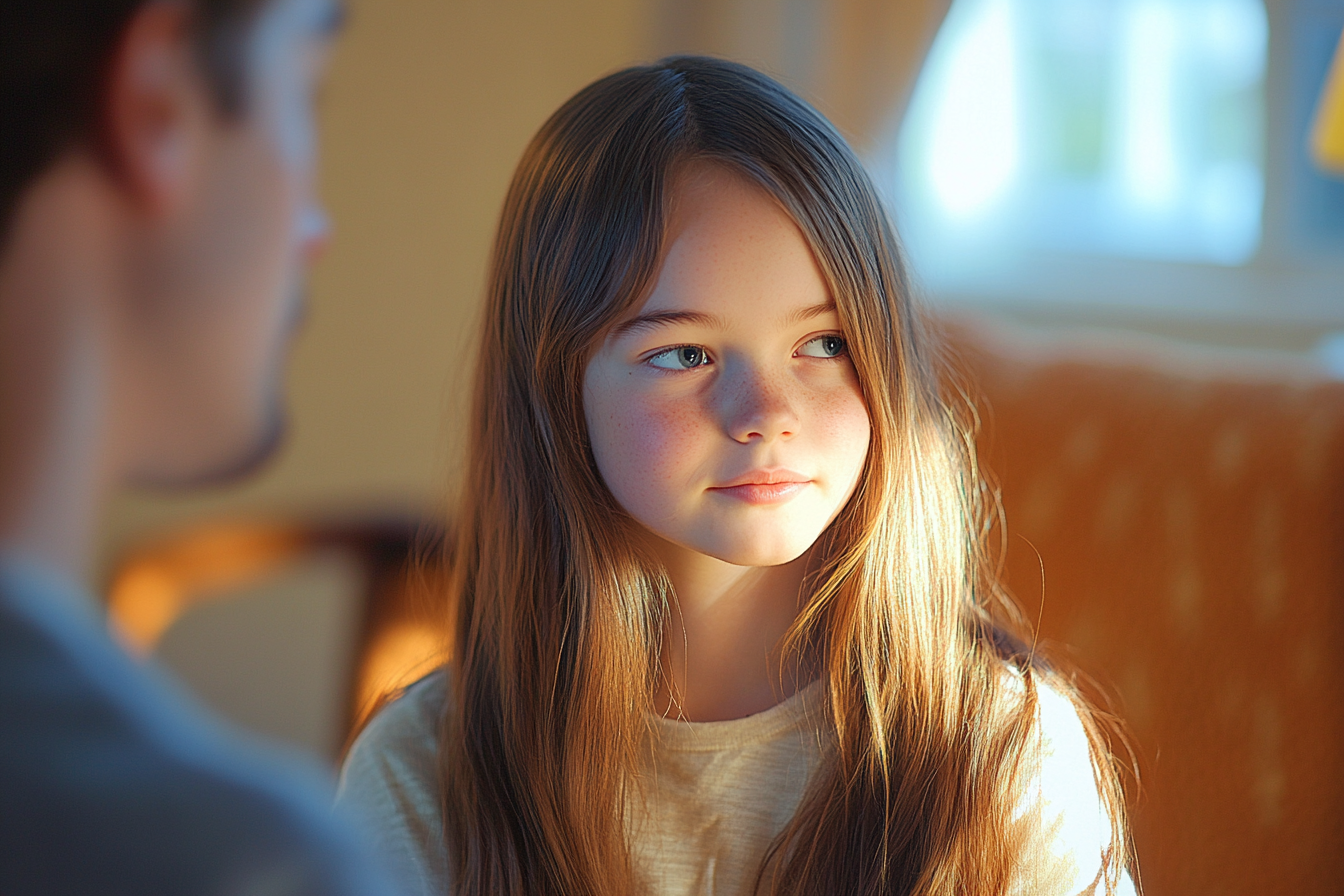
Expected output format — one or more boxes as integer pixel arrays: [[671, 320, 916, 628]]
[[108, 520, 448, 760]]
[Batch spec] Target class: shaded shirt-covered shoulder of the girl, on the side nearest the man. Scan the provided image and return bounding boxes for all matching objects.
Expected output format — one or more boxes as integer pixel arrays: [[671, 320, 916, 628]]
[[336, 669, 450, 895]]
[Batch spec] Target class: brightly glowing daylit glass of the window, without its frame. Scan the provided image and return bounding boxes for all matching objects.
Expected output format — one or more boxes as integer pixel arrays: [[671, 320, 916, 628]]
[[887, 0, 1269, 289]]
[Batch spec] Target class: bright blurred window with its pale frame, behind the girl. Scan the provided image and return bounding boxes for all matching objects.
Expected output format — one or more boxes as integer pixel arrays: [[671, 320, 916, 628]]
[[872, 0, 1344, 324]]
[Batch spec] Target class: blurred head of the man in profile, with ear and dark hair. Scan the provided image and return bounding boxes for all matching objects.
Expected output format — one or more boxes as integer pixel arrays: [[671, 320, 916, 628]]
[[0, 0, 340, 484]]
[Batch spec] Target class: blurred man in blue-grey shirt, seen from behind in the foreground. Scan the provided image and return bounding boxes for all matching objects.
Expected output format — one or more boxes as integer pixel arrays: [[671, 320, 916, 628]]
[[0, 0, 403, 896]]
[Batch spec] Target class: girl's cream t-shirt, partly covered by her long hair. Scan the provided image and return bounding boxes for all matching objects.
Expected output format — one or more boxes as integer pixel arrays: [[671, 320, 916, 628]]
[[337, 672, 1133, 896]]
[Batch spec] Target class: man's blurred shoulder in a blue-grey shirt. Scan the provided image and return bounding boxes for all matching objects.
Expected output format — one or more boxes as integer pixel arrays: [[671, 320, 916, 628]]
[[0, 561, 397, 893]]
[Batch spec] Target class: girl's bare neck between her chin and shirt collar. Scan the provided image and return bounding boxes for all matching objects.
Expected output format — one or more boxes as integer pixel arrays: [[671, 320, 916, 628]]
[[653, 544, 816, 721]]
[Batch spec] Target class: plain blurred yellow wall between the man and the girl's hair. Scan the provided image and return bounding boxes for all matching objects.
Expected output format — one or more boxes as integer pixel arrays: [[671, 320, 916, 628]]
[[105, 0, 652, 560]]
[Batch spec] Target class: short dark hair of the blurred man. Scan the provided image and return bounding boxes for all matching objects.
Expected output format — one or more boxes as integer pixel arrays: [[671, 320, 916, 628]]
[[0, 0, 265, 236]]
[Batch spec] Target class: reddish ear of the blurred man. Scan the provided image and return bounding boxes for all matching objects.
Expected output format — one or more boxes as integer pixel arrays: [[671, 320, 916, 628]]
[[102, 0, 214, 218]]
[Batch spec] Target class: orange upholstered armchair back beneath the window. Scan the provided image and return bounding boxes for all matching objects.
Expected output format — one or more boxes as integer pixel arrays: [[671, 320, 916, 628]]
[[948, 320, 1344, 896]]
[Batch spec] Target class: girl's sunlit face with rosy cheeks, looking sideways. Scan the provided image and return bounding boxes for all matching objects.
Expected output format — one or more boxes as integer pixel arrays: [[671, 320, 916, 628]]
[[583, 163, 868, 567]]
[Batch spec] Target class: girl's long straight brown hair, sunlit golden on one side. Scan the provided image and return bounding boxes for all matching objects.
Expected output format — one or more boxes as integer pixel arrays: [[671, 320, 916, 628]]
[[442, 56, 1126, 896]]
